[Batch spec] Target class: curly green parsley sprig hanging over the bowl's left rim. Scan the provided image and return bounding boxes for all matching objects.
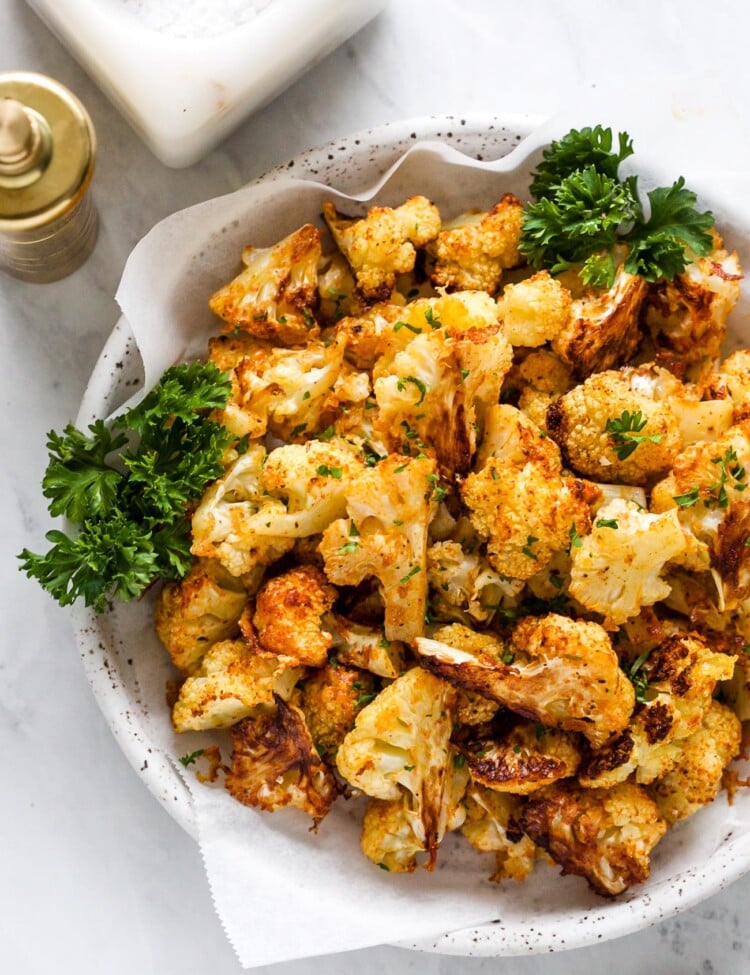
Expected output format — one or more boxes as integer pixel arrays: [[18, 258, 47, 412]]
[[19, 362, 233, 612]]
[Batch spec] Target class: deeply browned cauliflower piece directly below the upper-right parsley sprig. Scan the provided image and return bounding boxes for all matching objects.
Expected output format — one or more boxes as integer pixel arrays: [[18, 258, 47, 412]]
[[552, 266, 647, 379]]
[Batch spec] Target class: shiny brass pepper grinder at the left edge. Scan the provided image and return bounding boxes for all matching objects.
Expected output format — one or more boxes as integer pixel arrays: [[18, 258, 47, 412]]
[[0, 71, 98, 282]]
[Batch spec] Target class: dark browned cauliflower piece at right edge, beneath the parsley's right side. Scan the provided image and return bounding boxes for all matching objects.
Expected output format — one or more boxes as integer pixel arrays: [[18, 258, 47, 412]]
[[645, 231, 742, 376]]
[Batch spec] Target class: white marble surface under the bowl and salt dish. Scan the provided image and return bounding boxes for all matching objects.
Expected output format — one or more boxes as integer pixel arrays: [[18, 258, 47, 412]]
[[0, 0, 750, 975]]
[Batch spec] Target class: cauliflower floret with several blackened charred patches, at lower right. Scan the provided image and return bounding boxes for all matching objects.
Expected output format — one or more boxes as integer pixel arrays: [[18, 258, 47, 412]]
[[578, 633, 736, 788]]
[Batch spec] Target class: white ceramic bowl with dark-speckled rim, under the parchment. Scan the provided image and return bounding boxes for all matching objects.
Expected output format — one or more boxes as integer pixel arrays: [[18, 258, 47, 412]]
[[70, 116, 750, 955]]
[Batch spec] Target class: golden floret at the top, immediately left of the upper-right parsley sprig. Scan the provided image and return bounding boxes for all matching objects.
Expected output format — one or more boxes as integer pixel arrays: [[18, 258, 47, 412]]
[[429, 193, 523, 295]]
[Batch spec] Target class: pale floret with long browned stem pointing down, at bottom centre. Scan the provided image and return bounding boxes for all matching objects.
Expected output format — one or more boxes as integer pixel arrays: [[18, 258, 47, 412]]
[[336, 667, 458, 869]]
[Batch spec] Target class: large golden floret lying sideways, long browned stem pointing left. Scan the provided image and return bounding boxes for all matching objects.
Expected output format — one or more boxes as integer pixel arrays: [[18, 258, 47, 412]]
[[415, 613, 635, 747]]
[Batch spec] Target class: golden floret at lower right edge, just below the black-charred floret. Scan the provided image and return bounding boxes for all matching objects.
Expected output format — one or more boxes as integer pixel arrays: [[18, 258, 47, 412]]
[[649, 701, 742, 826]]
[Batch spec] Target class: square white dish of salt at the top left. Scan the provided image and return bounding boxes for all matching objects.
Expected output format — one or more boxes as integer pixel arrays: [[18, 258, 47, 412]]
[[22, 0, 387, 168]]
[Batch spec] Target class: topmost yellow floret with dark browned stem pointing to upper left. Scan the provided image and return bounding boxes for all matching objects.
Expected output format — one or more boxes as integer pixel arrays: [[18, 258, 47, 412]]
[[322, 196, 440, 301]]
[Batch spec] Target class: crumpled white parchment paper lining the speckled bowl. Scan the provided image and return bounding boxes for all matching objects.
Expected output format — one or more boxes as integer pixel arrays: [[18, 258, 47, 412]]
[[111, 79, 750, 968]]
